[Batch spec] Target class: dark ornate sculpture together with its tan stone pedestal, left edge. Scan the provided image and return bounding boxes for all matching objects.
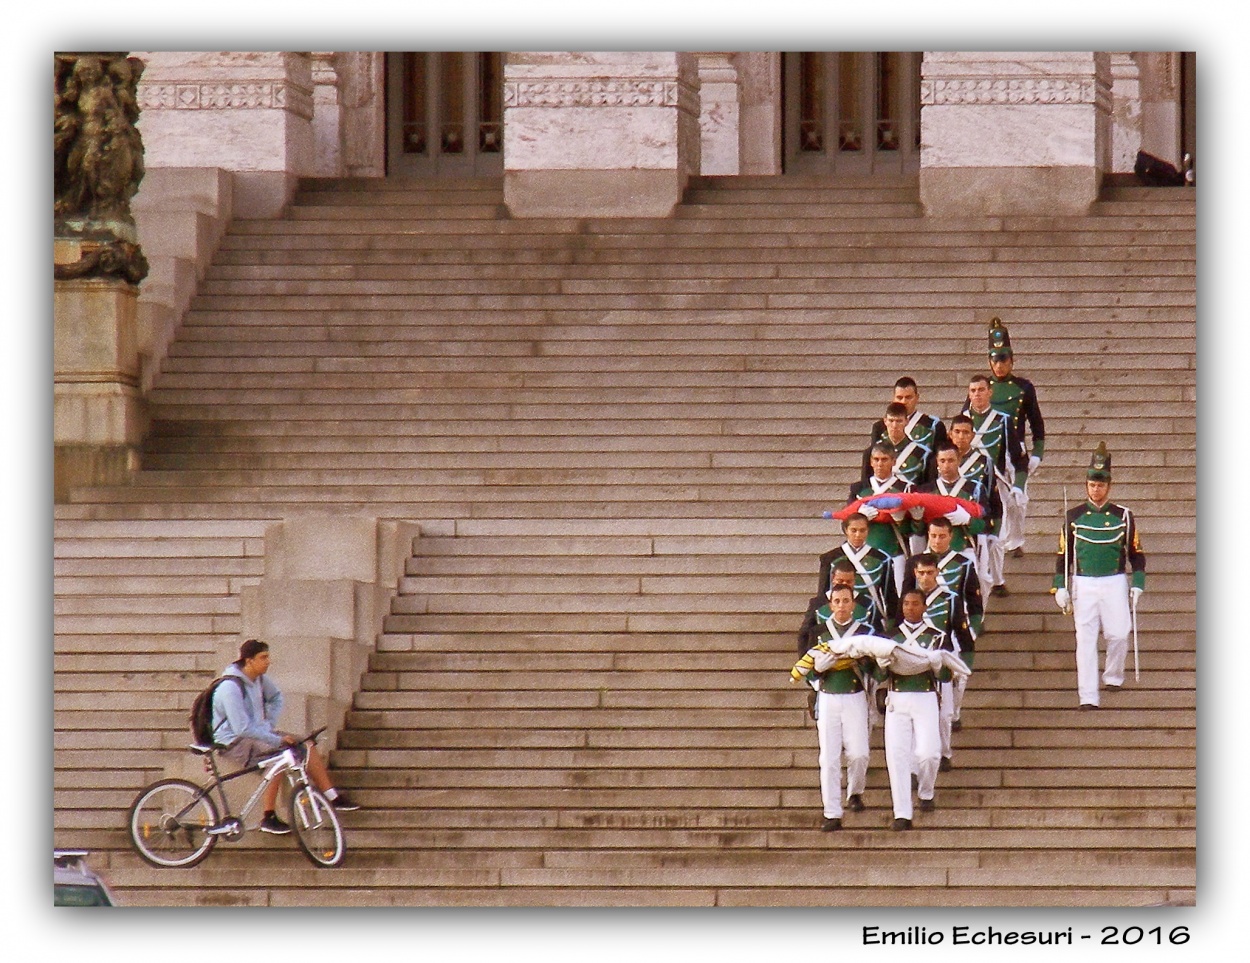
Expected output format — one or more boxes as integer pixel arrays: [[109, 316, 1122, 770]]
[[53, 53, 148, 502]]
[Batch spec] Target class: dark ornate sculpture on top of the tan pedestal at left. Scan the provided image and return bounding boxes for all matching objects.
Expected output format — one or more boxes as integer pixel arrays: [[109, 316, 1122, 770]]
[[53, 53, 148, 284]]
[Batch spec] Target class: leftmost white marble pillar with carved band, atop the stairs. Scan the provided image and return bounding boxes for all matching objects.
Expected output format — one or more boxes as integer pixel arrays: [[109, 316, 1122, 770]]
[[136, 51, 315, 218]]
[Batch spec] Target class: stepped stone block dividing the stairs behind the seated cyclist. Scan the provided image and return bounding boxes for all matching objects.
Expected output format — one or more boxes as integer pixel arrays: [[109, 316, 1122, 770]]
[[236, 514, 420, 745]]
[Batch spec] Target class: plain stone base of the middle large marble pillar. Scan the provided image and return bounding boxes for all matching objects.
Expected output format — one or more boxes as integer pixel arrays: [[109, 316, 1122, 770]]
[[504, 170, 686, 218]]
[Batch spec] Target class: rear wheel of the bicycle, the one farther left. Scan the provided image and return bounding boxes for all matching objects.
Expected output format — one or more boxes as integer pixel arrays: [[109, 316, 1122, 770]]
[[130, 779, 218, 868]]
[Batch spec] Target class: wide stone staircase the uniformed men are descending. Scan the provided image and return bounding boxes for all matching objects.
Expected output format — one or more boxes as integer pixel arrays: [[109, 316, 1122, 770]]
[[54, 178, 1196, 905]]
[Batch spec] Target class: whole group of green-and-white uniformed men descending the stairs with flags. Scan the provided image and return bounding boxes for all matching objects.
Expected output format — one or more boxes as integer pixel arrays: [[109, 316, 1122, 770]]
[[790, 318, 1145, 832]]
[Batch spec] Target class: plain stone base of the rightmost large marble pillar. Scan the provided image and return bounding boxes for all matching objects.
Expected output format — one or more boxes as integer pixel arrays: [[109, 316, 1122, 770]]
[[920, 168, 1101, 218]]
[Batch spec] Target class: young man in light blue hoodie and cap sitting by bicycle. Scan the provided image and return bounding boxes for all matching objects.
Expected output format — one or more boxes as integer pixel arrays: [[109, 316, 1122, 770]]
[[213, 639, 360, 835]]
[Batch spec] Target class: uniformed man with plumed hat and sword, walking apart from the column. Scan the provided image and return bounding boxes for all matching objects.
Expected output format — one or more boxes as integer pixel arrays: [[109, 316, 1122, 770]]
[[1051, 443, 1146, 709]]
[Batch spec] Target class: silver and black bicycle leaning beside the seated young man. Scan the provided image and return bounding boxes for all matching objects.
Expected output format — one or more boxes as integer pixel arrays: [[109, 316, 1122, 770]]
[[129, 725, 348, 868]]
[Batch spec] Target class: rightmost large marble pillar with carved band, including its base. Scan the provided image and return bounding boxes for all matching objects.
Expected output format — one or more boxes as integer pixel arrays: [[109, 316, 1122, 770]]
[[920, 51, 1111, 216]]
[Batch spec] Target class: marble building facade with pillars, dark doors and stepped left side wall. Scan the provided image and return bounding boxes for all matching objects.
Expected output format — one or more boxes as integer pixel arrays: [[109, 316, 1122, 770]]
[[56, 51, 1195, 490]]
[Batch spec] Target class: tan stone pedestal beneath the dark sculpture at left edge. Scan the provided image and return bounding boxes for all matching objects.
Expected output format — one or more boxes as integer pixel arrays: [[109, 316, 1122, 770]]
[[53, 239, 146, 502]]
